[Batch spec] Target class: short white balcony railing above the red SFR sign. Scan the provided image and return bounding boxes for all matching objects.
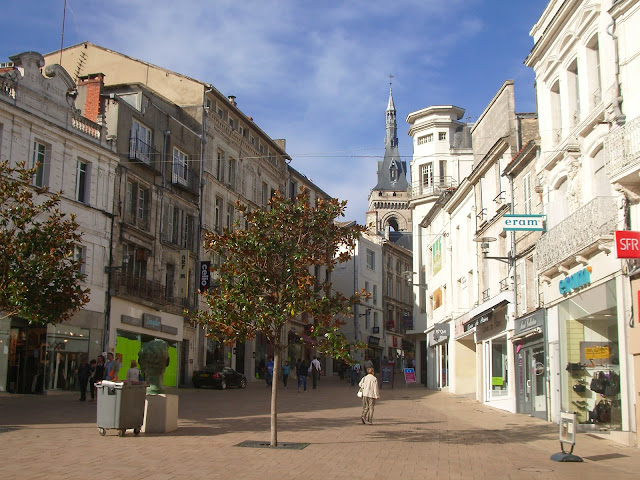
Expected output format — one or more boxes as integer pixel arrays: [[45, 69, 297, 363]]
[[604, 117, 640, 182]]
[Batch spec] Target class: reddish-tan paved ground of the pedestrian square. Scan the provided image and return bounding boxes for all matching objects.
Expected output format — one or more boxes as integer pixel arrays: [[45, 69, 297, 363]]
[[0, 378, 640, 480]]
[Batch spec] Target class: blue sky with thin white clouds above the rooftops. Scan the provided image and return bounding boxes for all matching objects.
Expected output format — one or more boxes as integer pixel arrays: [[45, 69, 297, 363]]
[[0, 0, 547, 223]]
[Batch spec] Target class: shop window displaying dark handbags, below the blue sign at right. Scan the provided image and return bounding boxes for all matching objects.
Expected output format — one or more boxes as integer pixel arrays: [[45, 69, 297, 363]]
[[558, 281, 622, 430]]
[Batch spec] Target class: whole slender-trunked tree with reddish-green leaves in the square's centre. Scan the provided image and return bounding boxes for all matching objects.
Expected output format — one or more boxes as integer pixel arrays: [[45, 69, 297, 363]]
[[194, 189, 366, 447]]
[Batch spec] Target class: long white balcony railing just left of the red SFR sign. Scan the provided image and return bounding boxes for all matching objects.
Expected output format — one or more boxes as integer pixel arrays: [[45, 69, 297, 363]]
[[536, 197, 618, 272]]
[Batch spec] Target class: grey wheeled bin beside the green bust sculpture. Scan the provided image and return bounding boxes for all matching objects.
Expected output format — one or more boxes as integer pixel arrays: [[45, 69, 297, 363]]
[[96, 380, 149, 437]]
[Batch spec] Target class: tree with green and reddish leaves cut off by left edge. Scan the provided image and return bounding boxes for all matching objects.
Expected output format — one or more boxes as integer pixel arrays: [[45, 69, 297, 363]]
[[0, 161, 89, 325]]
